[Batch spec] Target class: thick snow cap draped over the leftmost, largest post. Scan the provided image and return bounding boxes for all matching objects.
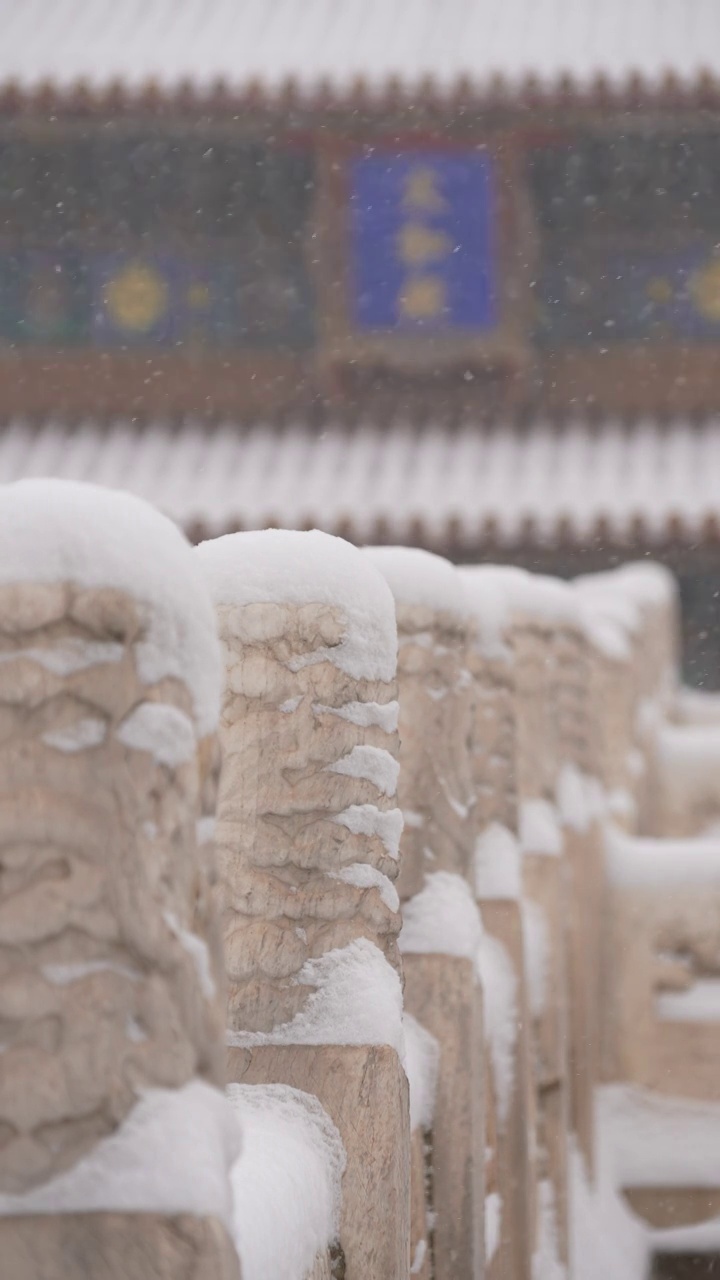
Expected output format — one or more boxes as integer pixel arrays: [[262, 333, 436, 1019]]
[[0, 480, 222, 736]]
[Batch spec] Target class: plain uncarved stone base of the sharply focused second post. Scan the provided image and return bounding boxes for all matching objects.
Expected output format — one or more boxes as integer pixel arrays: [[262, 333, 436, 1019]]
[[228, 1044, 410, 1280]]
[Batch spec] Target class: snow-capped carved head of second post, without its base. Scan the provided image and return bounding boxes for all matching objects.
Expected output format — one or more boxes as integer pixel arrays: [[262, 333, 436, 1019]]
[[197, 531, 401, 1033]]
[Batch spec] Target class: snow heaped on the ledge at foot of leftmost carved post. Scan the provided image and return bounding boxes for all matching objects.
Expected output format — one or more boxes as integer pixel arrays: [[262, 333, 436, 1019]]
[[0, 1080, 241, 1229]]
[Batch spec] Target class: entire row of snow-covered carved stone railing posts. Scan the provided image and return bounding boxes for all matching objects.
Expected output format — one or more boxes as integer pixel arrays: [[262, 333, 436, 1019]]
[[0, 481, 720, 1280]]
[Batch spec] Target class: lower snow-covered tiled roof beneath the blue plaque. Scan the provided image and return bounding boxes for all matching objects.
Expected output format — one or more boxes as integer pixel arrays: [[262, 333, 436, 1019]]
[[0, 419, 720, 553]]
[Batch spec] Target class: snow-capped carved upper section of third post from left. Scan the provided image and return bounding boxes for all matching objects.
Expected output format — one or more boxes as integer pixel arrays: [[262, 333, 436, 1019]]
[[365, 547, 474, 901]]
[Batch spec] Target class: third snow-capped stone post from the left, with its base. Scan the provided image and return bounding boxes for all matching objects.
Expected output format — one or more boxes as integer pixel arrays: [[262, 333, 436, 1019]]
[[365, 547, 484, 1280]]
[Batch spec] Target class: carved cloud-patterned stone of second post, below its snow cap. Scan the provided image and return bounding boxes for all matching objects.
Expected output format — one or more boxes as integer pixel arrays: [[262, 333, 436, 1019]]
[[210, 593, 400, 1032]]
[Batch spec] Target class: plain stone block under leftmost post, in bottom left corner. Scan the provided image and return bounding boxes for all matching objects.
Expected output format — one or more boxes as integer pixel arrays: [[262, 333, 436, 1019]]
[[0, 1213, 240, 1280]]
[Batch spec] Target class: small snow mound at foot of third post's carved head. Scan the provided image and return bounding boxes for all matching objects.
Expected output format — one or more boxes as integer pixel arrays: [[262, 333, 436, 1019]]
[[398, 872, 483, 960]]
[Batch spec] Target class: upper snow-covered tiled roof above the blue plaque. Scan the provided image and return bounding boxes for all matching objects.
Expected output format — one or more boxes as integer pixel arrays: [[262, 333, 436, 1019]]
[[0, 0, 720, 95]]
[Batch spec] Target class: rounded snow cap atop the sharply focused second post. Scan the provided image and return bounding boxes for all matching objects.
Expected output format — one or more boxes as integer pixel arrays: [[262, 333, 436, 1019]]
[[195, 529, 397, 680]]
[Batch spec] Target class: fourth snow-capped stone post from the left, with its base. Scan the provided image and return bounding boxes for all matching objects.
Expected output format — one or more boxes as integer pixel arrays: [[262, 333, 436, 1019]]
[[460, 567, 534, 1280]]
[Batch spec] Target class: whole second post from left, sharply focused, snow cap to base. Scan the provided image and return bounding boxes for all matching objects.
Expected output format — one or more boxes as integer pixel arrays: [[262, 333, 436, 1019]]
[[196, 530, 410, 1280]]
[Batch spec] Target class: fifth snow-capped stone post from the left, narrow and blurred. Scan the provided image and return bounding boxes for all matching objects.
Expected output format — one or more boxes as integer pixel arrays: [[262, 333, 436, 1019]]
[[511, 575, 580, 1266]]
